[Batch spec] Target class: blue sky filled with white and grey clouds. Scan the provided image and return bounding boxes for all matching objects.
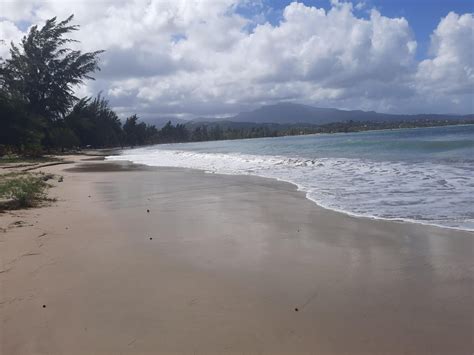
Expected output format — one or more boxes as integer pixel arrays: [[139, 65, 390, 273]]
[[0, 0, 474, 120]]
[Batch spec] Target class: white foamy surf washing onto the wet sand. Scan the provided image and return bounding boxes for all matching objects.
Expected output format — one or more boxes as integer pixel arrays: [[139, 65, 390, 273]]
[[108, 146, 474, 230]]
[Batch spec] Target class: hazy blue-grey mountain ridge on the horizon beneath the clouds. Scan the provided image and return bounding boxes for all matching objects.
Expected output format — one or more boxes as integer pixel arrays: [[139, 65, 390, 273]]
[[193, 103, 474, 125]]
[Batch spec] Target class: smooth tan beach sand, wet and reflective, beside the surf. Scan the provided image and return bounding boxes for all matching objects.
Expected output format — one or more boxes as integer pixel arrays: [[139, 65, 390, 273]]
[[0, 161, 474, 355]]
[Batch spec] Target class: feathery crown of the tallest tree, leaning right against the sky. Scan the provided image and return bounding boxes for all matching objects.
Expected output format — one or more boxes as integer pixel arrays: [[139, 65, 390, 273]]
[[0, 15, 103, 122]]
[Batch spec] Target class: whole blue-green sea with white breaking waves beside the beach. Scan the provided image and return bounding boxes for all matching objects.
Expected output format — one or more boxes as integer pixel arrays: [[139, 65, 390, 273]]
[[108, 125, 474, 230]]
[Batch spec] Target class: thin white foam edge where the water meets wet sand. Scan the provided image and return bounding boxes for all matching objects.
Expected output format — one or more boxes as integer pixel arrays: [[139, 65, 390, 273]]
[[104, 157, 474, 237]]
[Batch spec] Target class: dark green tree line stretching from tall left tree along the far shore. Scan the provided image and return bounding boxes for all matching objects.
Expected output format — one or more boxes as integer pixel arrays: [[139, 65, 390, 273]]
[[0, 16, 474, 156]]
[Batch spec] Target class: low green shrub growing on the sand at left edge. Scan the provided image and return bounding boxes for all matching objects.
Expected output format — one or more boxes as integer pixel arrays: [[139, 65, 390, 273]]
[[0, 174, 48, 208]]
